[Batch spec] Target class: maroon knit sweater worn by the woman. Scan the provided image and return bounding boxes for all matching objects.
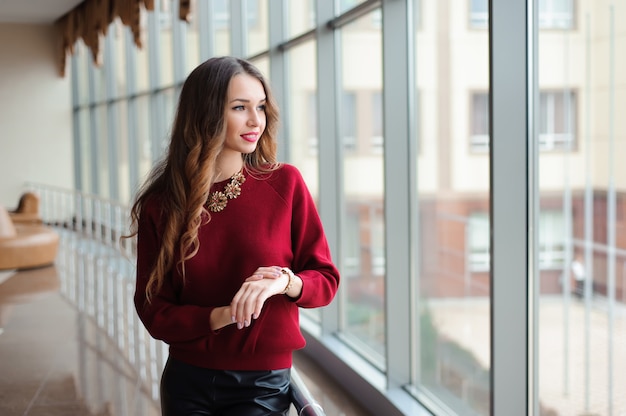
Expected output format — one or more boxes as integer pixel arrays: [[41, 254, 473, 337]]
[[135, 164, 339, 370]]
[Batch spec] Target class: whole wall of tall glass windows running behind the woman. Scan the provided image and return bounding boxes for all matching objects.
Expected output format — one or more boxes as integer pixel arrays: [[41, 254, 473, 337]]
[[63, 0, 626, 415]]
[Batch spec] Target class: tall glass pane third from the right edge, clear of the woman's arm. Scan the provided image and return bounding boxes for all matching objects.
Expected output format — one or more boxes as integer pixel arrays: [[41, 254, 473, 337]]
[[339, 13, 385, 366]]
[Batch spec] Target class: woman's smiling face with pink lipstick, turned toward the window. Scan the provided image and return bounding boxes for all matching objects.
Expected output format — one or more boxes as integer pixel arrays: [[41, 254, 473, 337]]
[[222, 74, 266, 154]]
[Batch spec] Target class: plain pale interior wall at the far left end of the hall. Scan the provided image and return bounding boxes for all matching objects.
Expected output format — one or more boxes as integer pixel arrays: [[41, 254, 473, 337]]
[[0, 24, 74, 209]]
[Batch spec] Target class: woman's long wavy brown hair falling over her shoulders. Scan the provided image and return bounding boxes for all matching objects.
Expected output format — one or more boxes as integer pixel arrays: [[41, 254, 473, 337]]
[[125, 57, 279, 301]]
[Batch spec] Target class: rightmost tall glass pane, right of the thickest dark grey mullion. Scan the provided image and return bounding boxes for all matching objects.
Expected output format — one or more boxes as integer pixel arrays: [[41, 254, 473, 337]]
[[534, 0, 626, 415]]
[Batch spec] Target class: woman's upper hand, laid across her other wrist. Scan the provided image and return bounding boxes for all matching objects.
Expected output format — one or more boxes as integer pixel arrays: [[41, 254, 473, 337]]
[[230, 266, 289, 329]]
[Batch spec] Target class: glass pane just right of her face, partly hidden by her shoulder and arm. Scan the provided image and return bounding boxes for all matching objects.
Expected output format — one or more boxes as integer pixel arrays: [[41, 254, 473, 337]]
[[284, 41, 320, 321]]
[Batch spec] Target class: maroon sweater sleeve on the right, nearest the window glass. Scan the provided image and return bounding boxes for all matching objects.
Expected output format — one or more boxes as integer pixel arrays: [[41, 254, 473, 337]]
[[284, 165, 339, 308]]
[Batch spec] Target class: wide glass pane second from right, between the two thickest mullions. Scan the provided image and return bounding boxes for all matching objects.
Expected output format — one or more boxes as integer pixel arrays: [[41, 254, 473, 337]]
[[414, 1, 491, 415]]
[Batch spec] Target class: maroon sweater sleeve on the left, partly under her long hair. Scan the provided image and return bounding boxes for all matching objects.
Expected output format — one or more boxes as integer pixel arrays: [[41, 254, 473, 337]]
[[134, 200, 214, 344]]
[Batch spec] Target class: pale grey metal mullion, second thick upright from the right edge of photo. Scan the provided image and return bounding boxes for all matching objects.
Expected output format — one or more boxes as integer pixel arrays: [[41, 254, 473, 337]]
[[382, 0, 417, 388]]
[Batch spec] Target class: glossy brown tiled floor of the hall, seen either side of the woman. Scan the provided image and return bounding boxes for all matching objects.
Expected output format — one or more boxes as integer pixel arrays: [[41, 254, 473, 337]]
[[0, 256, 369, 416]]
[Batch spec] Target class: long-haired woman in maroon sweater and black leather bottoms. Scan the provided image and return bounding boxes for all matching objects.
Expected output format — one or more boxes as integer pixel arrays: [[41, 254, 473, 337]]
[[131, 57, 339, 416]]
